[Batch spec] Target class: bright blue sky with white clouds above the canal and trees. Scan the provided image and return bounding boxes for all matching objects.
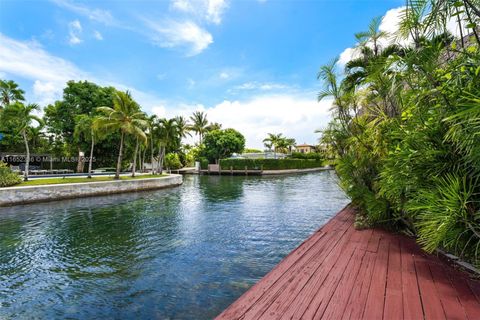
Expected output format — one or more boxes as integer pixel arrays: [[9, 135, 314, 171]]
[[0, 0, 404, 147]]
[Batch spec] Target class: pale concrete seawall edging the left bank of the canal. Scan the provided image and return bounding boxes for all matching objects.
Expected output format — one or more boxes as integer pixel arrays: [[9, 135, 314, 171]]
[[0, 174, 183, 207]]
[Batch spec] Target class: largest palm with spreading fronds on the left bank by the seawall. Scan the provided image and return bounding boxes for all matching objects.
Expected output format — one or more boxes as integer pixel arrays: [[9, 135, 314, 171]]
[[94, 91, 148, 179]]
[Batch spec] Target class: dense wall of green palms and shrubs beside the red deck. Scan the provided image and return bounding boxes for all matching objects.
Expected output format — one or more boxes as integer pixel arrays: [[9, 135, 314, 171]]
[[318, 1, 480, 266]]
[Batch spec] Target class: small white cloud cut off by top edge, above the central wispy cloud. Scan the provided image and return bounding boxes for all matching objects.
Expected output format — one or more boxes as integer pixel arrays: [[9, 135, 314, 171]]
[[171, 0, 228, 24]]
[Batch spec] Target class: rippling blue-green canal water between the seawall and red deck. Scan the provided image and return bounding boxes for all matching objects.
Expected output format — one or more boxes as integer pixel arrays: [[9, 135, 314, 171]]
[[0, 171, 349, 319]]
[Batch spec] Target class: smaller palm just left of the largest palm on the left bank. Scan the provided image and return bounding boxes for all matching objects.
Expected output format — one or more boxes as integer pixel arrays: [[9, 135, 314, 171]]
[[73, 114, 101, 178]]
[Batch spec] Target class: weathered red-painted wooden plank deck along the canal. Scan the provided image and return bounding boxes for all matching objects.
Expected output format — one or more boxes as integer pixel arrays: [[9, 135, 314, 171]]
[[217, 208, 480, 320]]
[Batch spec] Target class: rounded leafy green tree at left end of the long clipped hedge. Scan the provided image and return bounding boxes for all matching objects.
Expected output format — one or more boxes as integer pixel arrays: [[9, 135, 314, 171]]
[[202, 129, 245, 163]]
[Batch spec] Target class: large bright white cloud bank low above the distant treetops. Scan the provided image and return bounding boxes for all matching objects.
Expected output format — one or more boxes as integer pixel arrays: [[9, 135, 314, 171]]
[[169, 94, 331, 149]]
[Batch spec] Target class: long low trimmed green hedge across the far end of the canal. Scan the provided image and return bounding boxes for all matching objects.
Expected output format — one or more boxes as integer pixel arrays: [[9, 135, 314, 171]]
[[220, 159, 324, 170]]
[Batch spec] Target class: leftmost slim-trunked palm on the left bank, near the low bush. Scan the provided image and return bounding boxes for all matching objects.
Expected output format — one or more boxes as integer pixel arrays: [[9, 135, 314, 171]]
[[3, 102, 43, 181]]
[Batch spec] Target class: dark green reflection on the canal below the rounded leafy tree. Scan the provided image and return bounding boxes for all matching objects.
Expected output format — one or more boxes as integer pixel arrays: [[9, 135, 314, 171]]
[[199, 175, 246, 202]]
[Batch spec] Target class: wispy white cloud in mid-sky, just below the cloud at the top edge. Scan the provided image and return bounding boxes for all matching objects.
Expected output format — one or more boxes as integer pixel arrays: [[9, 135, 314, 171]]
[[145, 19, 213, 56]]
